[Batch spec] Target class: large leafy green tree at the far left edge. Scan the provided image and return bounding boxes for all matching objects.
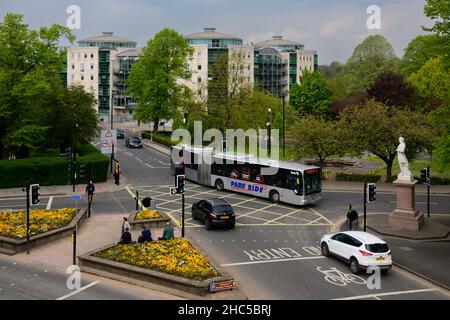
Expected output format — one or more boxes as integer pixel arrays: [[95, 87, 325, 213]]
[[0, 13, 75, 159]]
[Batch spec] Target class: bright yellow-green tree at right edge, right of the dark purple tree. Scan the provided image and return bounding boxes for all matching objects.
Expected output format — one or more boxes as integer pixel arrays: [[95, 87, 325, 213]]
[[408, 57, 450, 108]]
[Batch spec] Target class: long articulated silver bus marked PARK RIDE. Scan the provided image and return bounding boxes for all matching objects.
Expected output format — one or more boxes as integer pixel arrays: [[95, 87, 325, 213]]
[[171, 146, 322, 206]]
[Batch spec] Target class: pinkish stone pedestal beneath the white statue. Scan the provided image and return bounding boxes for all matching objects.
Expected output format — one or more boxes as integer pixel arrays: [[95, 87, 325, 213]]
[[388, 180, 425, 231]]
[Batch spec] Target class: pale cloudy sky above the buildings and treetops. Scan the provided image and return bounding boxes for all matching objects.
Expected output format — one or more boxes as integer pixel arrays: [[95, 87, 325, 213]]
[[0, 0, 432, 64]]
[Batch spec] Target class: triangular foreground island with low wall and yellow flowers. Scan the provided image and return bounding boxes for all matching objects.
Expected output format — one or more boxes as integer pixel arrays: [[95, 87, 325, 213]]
[[78, 239, 246, 300]]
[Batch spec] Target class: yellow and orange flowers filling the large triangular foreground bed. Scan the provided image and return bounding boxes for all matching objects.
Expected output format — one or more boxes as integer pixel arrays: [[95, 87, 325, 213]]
[[95, 239, 219, 280]]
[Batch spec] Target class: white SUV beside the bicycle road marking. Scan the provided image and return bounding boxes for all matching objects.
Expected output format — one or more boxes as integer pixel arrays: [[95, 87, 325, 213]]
[[320, 231, 392, 274]]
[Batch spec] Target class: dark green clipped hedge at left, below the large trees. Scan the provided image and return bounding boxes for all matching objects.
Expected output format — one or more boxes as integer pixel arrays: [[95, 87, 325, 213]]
[[0, 145, 109, 188]]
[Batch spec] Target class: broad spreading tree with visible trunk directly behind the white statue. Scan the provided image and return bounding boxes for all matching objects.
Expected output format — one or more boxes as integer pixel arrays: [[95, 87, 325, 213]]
[[339, 100, 435, 181]]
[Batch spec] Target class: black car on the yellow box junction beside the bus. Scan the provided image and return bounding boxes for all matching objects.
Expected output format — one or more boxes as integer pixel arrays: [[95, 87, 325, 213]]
[[192, 199, 236, 230]]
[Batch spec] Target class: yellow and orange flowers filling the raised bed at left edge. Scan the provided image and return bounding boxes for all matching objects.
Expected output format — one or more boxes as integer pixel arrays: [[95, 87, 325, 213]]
[[0, 209, 76, 240]]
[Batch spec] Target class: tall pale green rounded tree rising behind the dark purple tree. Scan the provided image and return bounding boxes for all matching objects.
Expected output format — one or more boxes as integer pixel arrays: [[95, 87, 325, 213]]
[[344, 35, 399, 94]]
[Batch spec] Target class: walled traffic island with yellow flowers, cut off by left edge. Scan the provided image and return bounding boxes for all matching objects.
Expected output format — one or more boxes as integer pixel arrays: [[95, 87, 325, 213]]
[[0, 209, 87, 255]]
